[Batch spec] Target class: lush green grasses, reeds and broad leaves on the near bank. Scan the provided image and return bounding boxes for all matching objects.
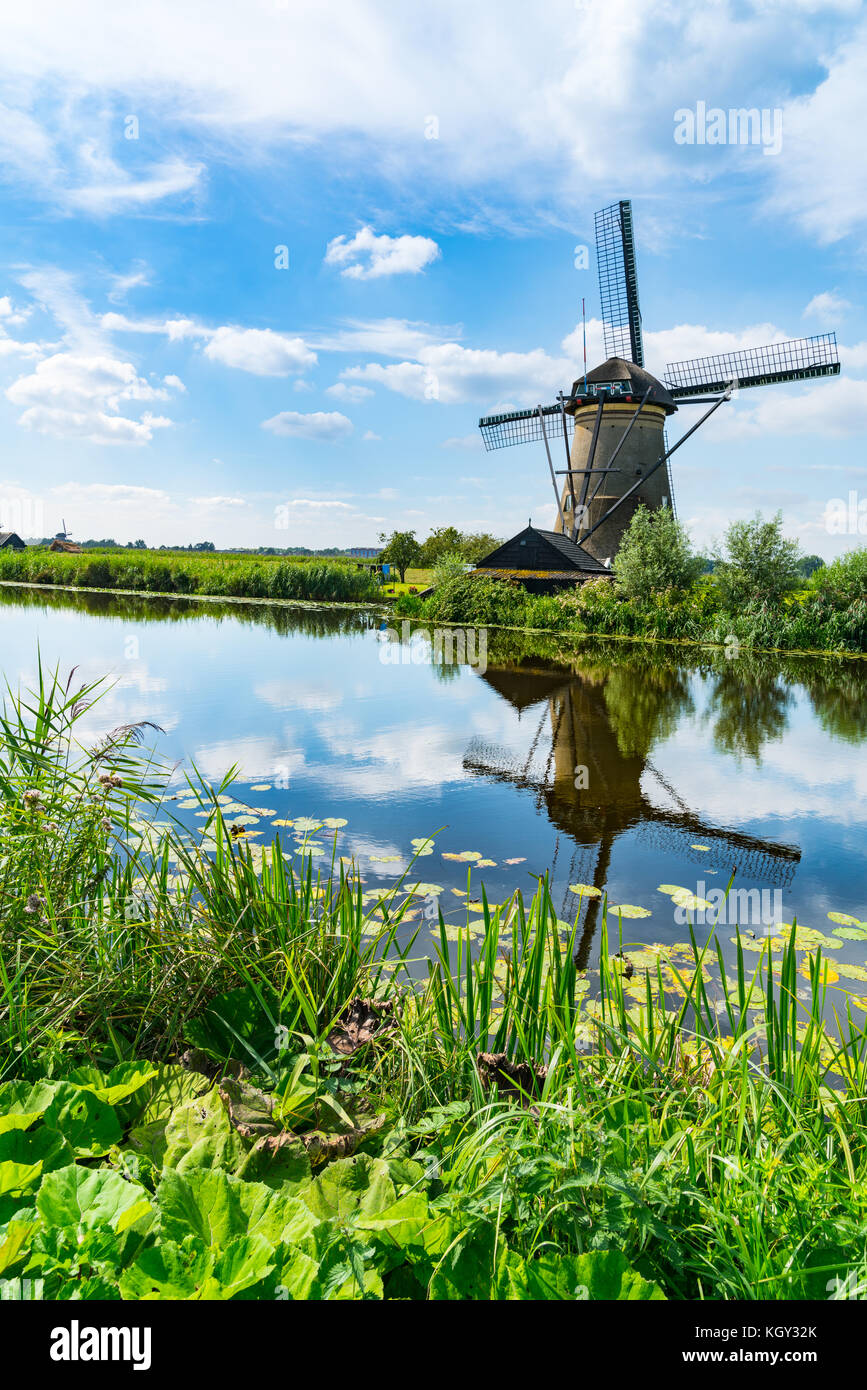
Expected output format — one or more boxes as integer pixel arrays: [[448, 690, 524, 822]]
[[0, 667, 867, 1301]]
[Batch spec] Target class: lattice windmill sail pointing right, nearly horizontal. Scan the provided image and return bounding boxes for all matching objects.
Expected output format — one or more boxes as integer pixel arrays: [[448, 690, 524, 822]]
[[664, 334, 839, 400]]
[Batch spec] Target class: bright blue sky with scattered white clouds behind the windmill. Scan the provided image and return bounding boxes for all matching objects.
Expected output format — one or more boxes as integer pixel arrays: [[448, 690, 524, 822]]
[[0, 0, 867, 559]]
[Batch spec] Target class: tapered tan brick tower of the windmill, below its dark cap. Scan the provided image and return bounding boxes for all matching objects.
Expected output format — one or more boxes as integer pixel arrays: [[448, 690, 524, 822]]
[[554, 402, 671, 563]]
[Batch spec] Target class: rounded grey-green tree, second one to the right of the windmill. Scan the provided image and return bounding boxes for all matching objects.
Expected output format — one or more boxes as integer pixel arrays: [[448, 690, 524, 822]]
[[714, 512, 800, 613]]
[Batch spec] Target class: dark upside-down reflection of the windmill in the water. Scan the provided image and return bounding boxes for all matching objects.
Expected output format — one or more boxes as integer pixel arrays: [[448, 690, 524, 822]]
[[463, 662, 800, 966]]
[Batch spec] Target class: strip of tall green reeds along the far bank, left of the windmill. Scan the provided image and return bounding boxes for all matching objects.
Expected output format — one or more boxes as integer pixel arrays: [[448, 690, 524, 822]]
[[0, 548, 379, 602]]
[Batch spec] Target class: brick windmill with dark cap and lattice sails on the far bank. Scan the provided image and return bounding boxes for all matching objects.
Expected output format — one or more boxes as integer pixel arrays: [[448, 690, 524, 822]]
[[479, 200, 841, 563]]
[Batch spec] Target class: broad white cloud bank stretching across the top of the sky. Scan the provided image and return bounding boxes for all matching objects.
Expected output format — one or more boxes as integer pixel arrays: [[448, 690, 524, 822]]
[[0, 0, 867, 241]]
